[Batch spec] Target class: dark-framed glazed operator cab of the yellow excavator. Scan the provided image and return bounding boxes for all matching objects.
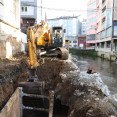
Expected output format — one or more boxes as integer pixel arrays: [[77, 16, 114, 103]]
[[52, 27, 64, 48]]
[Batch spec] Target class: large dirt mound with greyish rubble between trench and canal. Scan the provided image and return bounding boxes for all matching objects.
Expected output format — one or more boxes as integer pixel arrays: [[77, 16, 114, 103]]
[[38, 58, 117, 117]]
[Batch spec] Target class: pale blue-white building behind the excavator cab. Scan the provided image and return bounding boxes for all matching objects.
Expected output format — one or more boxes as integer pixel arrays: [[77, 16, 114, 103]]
[[48, 16, 81, 48]]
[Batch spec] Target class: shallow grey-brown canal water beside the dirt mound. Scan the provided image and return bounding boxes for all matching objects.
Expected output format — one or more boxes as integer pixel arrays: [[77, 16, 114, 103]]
[[73, 55, 117, 94]]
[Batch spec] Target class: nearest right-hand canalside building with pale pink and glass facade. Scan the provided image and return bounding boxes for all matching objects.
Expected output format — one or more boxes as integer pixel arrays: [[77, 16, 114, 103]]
[[87, 0, 117, 59]]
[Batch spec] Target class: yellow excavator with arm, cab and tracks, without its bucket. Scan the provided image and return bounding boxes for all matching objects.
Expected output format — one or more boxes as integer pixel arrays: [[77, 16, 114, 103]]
[[27, 22, 68, 81]]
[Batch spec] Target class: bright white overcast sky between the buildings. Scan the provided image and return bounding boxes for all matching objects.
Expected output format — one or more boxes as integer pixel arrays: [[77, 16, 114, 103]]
[[38, 0, 87, 19]]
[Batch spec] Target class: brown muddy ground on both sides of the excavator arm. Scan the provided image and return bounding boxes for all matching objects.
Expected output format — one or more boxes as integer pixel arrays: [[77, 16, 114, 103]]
[[0, 54, 117, 117]]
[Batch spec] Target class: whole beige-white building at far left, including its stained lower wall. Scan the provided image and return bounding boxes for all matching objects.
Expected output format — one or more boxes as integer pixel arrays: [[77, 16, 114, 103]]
[[0, 0, 21, 58]]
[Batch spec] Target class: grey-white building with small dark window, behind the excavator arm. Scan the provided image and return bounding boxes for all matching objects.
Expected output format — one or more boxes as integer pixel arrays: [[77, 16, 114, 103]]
[[21, 0, 38, 33]]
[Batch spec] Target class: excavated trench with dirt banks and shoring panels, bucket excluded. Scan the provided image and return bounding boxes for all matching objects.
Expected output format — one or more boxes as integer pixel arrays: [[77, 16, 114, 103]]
[[0, 53, 117, 117]]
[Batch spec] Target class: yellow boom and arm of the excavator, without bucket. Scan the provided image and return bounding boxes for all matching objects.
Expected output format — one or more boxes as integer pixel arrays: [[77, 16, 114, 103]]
[[27, 23, 51, 81]]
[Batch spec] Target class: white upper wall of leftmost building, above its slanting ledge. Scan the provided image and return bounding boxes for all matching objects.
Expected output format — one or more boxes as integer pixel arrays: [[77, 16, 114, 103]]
[[0, 0, 20, 29]]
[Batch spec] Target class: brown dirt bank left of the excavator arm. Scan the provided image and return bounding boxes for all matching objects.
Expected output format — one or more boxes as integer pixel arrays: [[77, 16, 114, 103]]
[[0, 53, 28, 110]]
